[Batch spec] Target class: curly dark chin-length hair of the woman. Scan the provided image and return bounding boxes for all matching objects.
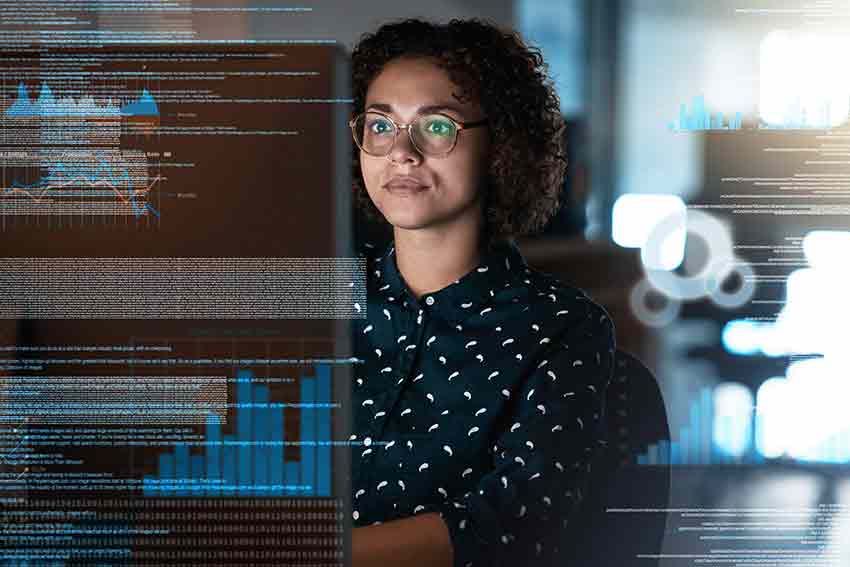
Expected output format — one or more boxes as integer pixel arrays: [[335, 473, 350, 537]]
[[352, 19, 567, 246]]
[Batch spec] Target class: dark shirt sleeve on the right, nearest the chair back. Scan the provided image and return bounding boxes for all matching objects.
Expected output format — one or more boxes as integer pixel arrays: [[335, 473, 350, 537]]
[[430, 301, 615, 567]]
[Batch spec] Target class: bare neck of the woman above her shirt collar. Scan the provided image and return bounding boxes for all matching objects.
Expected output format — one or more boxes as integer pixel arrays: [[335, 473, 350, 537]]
[[393, 225, 482, 299]]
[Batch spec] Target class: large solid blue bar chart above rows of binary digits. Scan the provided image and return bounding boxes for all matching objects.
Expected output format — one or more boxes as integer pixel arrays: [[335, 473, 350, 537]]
[[142, 364, 331, 497]]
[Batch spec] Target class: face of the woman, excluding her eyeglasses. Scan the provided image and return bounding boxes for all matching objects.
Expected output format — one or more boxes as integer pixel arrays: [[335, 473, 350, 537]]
[[360, 58, 488, 237]]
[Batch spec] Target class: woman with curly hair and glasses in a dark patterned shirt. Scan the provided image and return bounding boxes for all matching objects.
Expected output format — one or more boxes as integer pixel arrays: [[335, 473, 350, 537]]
[[350, 20, 614, 567]]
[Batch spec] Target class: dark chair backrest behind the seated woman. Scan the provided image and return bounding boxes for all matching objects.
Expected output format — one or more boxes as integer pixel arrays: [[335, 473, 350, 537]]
[[565, 351, 670, 567]]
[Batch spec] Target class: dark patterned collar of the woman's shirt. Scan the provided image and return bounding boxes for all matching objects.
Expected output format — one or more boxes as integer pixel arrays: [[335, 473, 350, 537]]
[[375, 240, 528, 325]]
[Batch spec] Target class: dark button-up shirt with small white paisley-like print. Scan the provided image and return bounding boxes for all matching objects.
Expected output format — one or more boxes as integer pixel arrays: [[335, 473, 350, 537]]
[[350, 237, 614, 567]]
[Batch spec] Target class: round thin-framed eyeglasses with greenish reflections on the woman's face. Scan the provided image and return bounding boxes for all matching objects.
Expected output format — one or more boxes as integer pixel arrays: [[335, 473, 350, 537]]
[[348, 111, 487, 158]]
